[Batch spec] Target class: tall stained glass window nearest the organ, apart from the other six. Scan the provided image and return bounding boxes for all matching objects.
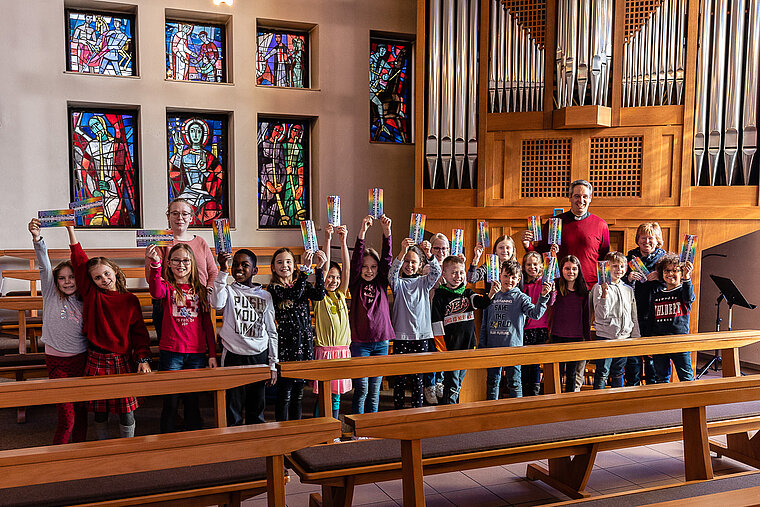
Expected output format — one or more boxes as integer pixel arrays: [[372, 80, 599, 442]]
[[369, 37, 412, 143]]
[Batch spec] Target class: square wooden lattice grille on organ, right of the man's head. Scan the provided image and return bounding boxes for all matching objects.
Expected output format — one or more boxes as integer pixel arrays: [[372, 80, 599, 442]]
[[589, 136, 644, 197]]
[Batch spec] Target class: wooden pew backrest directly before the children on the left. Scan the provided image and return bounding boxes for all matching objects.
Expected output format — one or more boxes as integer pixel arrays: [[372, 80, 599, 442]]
[[0, 365, 271, 428]]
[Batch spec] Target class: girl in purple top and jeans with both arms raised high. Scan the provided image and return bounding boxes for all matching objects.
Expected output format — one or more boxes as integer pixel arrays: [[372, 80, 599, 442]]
[[348, 215, 396, 414]]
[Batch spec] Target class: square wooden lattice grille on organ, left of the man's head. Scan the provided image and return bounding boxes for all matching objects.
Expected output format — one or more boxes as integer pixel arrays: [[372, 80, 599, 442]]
[[520, 139, 571, 197]]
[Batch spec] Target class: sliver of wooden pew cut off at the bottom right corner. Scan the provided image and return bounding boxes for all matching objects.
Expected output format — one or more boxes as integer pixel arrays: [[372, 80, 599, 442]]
[[552, 472, 760, 507]]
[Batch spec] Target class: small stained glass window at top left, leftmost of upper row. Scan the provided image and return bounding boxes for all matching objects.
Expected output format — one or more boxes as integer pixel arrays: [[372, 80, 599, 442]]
[[66, 10, 135, 76]]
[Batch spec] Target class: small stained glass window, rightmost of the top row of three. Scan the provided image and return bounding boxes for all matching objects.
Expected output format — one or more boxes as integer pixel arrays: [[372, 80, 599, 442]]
[[256, 30, 309, 88]]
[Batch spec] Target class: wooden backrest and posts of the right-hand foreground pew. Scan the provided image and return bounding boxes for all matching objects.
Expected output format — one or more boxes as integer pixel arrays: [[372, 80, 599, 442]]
[[346, 375, 760, 506]]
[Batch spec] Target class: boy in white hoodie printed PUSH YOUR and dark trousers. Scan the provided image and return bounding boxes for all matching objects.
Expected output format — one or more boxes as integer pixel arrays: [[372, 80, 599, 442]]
[[209, 248, 277, 426]]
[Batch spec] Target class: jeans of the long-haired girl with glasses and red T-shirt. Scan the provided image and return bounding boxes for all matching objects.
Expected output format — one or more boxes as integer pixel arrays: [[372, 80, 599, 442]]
[[159, 350, 208, 433]]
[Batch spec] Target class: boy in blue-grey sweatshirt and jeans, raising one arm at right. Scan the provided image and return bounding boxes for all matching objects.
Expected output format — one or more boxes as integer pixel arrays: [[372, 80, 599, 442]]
[[478, 260, 554, 400]]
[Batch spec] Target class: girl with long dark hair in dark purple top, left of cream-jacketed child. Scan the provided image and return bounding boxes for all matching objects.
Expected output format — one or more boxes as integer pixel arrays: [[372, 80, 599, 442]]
[[550, 255, 591, 392]]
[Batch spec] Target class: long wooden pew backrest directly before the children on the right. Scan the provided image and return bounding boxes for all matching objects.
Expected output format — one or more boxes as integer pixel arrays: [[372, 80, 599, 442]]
[[277, 330, 760, 420]]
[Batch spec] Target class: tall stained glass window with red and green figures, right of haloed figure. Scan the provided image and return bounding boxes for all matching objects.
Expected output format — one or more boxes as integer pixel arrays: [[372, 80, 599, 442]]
[[258, 118, 309, 228]]
